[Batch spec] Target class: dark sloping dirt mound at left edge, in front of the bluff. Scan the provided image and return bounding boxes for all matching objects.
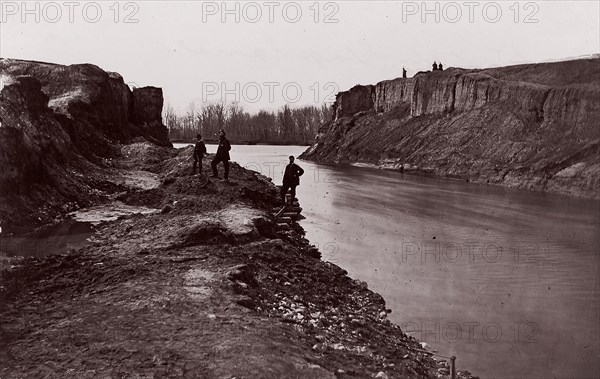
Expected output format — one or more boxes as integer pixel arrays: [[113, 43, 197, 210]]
[[0, 77, 107, 233]]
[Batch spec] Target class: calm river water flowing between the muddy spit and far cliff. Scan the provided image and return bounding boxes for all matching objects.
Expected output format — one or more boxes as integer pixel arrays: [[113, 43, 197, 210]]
[[185, 145, 600, 379]]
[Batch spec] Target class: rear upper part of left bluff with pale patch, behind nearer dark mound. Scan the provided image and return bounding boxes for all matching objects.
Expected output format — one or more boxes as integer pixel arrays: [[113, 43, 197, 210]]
[[0, 59, 172, 155]]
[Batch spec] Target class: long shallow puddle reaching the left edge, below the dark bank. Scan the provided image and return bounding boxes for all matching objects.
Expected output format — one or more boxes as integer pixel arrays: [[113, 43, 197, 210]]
[[0, 202, 159, 258]]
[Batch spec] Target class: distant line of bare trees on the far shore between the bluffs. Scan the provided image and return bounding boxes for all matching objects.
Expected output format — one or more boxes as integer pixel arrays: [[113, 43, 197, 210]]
[[163, 103, 332, 145]]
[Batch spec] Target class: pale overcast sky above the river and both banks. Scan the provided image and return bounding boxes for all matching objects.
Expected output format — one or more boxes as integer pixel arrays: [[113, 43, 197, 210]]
[[0, 0, 600, 111]]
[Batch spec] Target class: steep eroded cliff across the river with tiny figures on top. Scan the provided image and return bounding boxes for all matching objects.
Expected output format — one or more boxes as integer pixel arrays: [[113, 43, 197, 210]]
[[303, 59, 600, 198]]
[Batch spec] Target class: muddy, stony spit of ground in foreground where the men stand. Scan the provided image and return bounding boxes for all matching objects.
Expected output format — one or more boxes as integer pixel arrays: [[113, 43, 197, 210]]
[[0, 144, 478, 379]]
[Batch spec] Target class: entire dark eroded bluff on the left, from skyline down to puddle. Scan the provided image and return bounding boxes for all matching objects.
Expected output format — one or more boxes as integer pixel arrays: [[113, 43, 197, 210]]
[[0, 59, 171, 235]]
